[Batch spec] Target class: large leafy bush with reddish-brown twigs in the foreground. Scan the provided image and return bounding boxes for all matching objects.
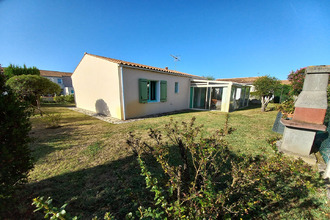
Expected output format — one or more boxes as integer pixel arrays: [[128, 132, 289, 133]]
[[128, 119, 324, 219]]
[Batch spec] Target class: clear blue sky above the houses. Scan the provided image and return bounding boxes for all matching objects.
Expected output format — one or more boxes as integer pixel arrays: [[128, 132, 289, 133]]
[[0, 0, 330, 79]]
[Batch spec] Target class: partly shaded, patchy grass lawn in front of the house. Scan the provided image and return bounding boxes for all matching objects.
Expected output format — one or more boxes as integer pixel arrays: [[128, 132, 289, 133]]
[[6, 104, 324, 219]]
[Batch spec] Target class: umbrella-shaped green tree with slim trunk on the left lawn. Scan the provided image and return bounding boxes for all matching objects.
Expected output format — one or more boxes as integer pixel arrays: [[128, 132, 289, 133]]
[[6, 75, 61, 115]]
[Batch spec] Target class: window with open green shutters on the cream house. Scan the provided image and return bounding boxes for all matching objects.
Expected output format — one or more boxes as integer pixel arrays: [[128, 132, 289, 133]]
[[139, 79, 167, 103]]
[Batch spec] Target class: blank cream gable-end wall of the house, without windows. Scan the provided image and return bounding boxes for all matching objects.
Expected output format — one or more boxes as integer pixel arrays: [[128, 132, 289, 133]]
[[72, 54, 122, 119]]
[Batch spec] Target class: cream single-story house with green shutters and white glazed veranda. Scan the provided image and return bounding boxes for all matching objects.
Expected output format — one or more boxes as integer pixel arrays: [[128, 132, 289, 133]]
[[72, 53, 249, 120]]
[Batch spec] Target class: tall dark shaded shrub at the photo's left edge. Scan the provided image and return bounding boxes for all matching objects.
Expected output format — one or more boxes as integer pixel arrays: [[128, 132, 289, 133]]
[[0, 68, 33, 210]]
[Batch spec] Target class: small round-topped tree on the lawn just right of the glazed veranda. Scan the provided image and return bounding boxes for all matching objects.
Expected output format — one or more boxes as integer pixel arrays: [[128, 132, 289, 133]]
[[253, 76, 281, 112]]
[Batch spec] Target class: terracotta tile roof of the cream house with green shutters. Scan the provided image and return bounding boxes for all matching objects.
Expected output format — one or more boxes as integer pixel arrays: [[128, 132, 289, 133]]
[[85, 53, 203, 78]]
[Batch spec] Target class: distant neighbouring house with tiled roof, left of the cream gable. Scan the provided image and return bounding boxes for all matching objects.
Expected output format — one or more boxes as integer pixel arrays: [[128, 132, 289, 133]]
[[40, 70, 74, 95]]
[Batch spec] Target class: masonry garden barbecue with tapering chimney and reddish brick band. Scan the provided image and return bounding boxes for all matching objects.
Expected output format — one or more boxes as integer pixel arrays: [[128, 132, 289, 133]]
[[280, 65, 330, 156]]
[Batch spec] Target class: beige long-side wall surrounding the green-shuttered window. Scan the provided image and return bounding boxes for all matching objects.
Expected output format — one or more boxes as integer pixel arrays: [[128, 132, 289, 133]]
[[123, 67, 190, 119]]
